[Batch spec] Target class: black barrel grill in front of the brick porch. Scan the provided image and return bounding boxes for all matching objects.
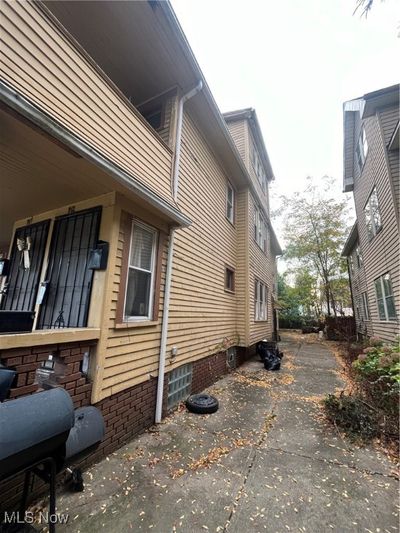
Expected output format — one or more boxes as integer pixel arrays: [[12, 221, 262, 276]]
[[0, 367, 105, 532]]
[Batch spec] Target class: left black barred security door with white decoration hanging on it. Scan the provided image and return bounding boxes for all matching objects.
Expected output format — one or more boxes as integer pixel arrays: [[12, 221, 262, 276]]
[[0, 220, 50, 311]]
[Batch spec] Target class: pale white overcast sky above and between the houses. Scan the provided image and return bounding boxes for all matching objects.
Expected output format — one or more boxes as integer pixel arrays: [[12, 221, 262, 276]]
[[172, 0, 400, 222]]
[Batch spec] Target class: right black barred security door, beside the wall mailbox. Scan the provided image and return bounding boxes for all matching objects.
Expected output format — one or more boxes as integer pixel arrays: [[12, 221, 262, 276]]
[[37, 207, 101, 329]]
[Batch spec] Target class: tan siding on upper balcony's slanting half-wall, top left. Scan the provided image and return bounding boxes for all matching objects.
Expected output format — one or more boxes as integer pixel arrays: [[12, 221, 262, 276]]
[[0, 2, 172, 204]]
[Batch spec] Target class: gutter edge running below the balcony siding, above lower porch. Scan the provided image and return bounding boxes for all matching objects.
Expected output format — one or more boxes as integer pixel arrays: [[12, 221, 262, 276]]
[[0, 80, 191, 226]]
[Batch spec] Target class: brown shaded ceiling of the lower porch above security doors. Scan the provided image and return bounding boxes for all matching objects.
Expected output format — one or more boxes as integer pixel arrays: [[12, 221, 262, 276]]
[[0, 109, 113, 244]]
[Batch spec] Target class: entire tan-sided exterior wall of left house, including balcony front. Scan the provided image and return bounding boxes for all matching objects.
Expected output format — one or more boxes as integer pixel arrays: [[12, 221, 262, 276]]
[[0, 2, 282, 402]]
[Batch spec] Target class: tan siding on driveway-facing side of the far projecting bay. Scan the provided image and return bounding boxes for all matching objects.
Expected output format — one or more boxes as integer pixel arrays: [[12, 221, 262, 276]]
[[248, 193, 275, 345]]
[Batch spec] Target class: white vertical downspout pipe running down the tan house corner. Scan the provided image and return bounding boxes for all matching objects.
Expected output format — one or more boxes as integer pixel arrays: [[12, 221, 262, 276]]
[[155, 80, 203, 424]]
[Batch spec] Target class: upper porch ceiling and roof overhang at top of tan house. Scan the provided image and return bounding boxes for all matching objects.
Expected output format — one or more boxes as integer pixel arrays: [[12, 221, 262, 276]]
[[43, 0, 247, 188]]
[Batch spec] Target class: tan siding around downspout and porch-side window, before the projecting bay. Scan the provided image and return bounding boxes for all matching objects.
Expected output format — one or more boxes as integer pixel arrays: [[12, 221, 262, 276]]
[[99, 115, 244, 397]]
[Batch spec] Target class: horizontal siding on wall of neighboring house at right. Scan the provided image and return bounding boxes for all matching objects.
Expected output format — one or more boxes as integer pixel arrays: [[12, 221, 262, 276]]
[[354, 111, 400, 340]]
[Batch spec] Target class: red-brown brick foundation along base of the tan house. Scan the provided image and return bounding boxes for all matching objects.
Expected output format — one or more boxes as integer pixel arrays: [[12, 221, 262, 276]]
[[0, 343, 241, 510]]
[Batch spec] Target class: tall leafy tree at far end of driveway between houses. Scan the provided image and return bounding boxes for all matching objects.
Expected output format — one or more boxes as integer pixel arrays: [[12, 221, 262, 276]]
[[282, 177, 351, 315]]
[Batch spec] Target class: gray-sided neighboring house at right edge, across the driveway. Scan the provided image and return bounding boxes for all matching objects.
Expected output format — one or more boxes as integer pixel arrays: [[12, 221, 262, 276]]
[[343, 85, 400, 341]]
